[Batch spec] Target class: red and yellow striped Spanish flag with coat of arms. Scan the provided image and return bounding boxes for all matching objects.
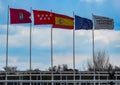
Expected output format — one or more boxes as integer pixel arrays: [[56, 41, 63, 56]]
[[53, 14, 74, 29]]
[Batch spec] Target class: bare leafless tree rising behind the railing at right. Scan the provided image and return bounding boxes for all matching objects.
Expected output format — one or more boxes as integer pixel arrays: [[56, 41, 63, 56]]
[[87, 51, 111, 71]]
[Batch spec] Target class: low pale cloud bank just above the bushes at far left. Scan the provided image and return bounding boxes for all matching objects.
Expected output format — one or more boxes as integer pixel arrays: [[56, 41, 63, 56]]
[[0, 56, 50, 70]]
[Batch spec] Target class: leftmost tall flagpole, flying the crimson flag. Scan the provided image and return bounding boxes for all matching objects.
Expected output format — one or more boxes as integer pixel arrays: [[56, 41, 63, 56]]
[[5, 5, 9, 85]]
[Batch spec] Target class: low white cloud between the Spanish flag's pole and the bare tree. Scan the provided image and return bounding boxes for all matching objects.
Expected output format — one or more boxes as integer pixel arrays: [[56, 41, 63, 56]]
[[53, 53, 91, 69]]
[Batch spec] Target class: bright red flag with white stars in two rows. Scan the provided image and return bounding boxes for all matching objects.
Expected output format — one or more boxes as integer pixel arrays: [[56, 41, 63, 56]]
[[33, 10, 54, 25]]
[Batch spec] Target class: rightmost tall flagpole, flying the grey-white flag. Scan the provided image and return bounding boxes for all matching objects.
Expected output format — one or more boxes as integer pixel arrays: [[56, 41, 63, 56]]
[[92, 14, 95, 85]]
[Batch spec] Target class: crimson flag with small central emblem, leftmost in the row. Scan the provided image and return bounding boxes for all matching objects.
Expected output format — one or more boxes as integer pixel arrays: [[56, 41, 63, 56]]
[[10, 8, 31, 24]]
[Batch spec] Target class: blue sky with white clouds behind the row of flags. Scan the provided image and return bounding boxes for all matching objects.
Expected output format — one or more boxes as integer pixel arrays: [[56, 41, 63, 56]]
[[0, 0, 120, 70]]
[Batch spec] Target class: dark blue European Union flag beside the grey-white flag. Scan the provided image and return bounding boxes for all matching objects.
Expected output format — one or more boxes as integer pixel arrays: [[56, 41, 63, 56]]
[[75, 15, 93, 30]]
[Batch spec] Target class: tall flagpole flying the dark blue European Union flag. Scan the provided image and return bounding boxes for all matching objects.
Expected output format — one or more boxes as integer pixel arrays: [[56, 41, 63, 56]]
[[73, 12, 75, 85]]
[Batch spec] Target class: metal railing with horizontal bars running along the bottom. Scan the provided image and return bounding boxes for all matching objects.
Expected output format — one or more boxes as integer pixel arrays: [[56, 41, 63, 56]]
[[0, 71, 120, 85]]
